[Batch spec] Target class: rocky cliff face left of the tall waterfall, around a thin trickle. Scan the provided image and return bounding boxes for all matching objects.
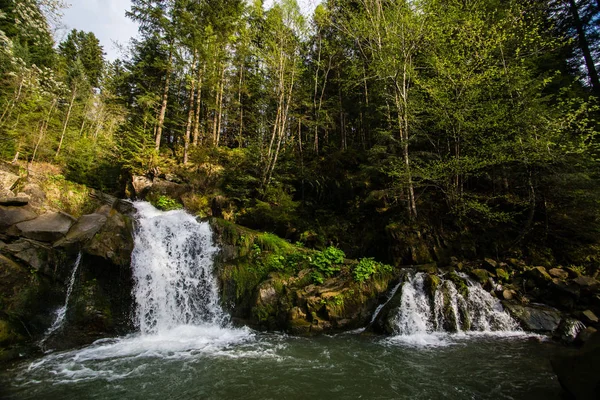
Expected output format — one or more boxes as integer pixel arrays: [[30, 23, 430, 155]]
[[0, 163, 133, 359]]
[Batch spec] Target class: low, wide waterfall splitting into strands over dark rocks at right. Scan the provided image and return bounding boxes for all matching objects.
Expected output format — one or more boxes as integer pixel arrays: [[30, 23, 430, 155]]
[[393, 272, 519, 336]]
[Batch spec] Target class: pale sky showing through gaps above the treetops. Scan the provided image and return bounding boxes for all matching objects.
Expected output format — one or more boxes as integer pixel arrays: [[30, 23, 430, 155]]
[[55, 0, 320, 61]]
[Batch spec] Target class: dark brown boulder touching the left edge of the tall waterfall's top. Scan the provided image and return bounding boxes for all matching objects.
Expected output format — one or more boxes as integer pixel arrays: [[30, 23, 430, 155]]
[[83, 213, 133, 267]]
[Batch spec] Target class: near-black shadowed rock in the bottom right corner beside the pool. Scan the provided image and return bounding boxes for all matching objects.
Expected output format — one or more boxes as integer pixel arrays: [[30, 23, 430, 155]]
[[551, 332, 600, 399]]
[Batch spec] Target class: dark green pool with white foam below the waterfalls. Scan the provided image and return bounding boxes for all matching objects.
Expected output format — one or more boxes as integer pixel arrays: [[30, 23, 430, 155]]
[[0, 325, 567, 400]]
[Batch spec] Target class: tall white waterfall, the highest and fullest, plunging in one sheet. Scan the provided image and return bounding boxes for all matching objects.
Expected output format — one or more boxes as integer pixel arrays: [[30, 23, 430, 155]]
[[131, 202, 226, 334]]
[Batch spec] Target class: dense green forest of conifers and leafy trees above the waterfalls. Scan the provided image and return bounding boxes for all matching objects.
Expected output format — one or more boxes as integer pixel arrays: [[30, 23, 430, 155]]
[[0, 0, 600, 274]]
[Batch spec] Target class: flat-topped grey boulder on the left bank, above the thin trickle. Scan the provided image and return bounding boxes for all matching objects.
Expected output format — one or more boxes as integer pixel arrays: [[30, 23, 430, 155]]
[[15, 212, 76, 242]]
